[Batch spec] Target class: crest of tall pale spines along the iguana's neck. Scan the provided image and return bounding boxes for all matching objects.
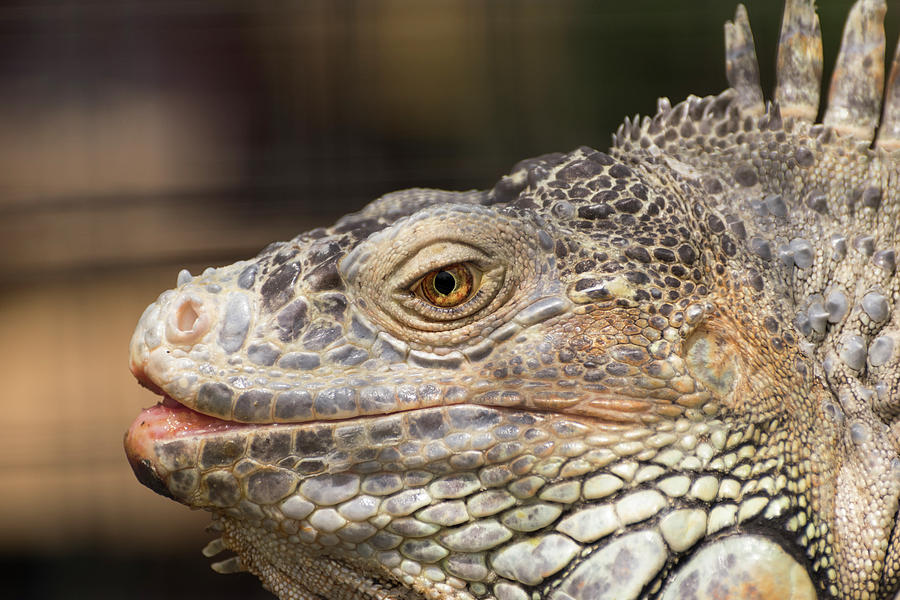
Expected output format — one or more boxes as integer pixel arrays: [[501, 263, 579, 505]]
[[613, 0, 900, 151]]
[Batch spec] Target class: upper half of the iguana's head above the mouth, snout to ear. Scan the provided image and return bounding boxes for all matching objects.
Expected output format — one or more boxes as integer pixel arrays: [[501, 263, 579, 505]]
[[131, 148, 720, 436]]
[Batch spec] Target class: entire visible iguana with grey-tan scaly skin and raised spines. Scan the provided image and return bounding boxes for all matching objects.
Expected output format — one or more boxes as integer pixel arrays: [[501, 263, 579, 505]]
[[126, 0, 900, 600]]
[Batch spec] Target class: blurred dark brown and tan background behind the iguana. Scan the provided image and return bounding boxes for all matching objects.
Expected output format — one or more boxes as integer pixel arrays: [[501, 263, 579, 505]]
[[0, 0, 900, 600]]
